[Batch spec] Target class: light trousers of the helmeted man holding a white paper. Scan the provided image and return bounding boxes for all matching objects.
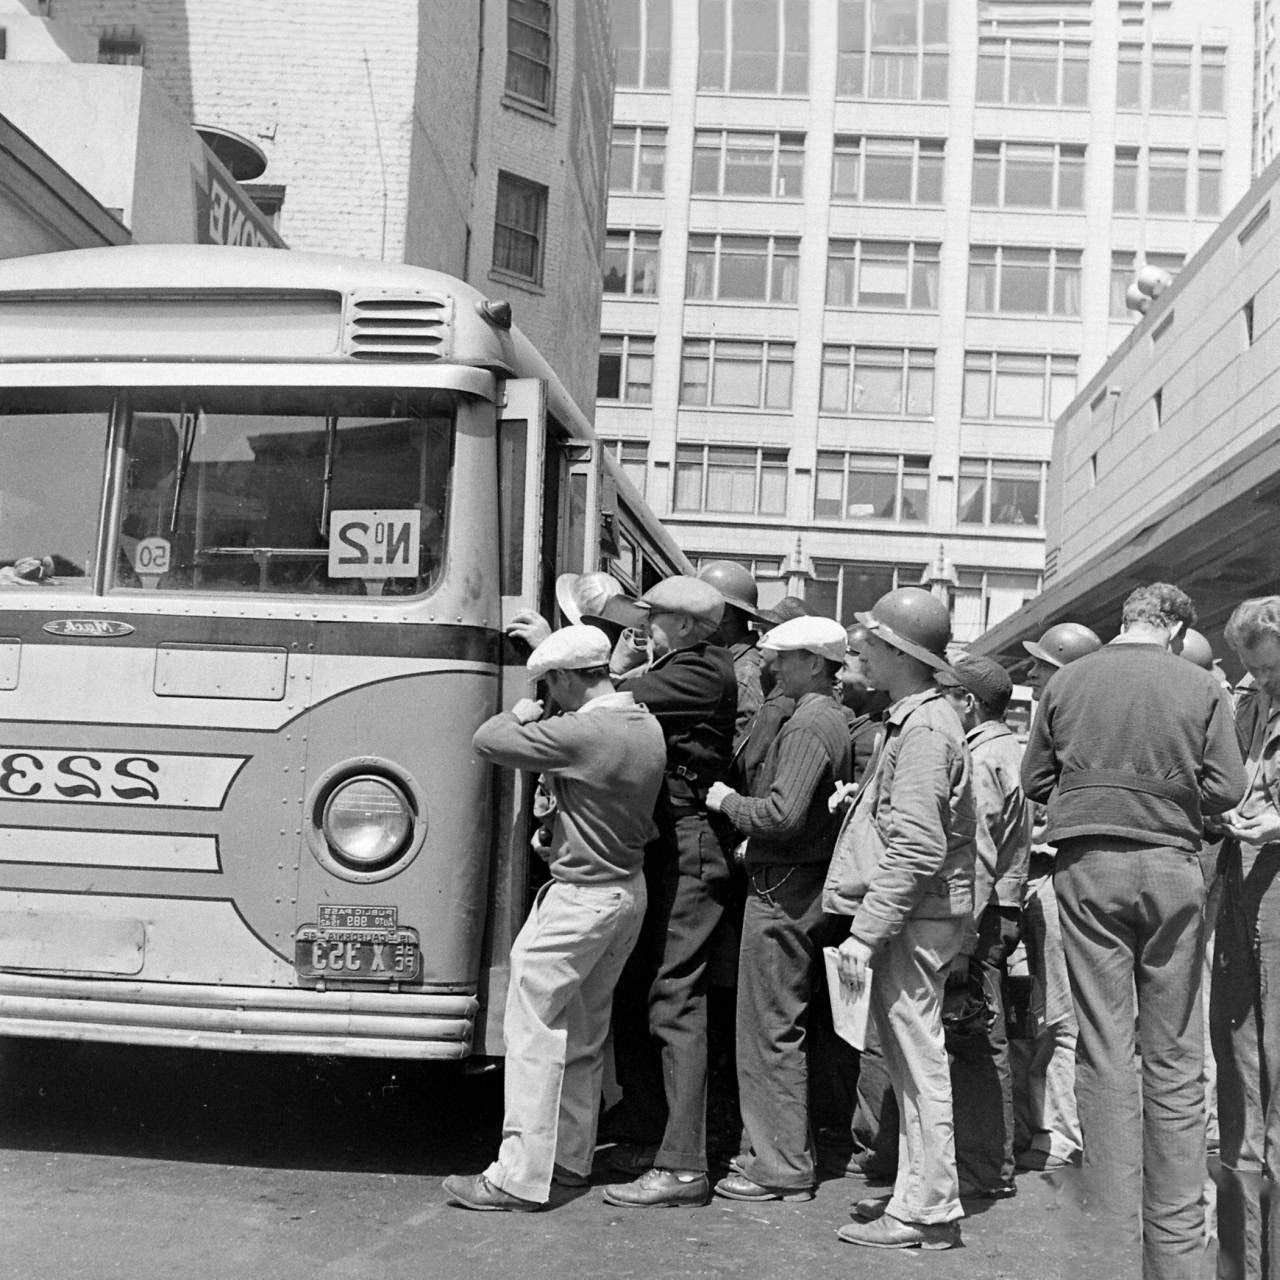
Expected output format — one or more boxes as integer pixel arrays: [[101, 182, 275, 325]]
[[870, 916, 965, 1222]]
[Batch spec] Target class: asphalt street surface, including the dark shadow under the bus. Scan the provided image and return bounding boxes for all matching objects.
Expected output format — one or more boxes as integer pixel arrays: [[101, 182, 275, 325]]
[[0, 1039, 1212, 1280]]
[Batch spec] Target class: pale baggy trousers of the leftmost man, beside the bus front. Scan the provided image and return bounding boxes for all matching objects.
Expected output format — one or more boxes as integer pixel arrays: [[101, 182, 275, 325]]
[[485, 874, 645, 1203]]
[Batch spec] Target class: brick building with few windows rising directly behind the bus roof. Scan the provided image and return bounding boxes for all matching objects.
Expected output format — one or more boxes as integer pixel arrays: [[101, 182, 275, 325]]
[[37, 0, 613, 416]]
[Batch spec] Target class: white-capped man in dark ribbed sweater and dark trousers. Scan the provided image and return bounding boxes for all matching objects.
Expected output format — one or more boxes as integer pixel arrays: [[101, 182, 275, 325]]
[[707, 617, 851, 1201]]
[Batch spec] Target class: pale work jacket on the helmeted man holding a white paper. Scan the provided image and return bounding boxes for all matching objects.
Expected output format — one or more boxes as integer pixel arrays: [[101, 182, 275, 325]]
[[822, 689, 977, 948]]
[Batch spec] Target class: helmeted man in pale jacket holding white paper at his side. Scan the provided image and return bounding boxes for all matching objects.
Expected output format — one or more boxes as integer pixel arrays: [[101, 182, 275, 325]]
[[823, 588, 975, 1249]]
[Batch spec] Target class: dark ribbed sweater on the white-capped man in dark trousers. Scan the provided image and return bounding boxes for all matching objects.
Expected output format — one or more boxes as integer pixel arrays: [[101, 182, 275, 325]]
[[721, 692, 850, 869]]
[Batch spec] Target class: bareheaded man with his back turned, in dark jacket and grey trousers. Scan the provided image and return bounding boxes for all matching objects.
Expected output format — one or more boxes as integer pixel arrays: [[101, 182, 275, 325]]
[[1021, 582, 1245, 1280]]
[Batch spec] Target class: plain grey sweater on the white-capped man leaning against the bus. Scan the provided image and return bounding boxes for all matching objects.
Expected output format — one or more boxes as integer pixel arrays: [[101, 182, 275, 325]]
[[472, 692, 667, 884]]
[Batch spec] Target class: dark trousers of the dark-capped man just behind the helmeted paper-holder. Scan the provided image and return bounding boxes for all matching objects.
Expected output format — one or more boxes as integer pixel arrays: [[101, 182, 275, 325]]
[[948, 904, 1021, 1189]]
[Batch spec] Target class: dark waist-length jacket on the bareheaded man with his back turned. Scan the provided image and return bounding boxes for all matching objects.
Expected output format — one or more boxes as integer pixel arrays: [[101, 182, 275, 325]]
[[1021, 643, 1245, 852]]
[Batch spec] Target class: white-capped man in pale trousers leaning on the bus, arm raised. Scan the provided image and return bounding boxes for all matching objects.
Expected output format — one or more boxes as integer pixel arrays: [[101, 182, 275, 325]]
[[444, 626, 667, 1212]]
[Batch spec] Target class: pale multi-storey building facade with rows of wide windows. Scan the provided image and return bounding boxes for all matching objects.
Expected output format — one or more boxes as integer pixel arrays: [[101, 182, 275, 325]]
[[596, 0, 1254, 639]]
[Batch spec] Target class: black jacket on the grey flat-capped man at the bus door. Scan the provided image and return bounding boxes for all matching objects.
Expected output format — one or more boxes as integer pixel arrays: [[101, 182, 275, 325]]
[[618, 640, 737, 810]]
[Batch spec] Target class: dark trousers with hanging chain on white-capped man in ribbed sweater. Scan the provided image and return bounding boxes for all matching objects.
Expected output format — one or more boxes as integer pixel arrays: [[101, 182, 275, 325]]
[[733, 863, 827, 1190]]
